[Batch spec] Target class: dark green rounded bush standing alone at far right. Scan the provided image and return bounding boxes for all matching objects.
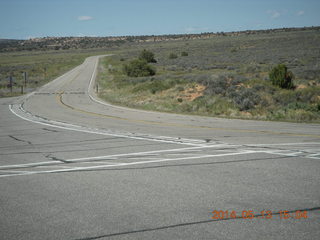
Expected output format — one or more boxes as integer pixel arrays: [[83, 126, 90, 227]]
[[269, 64, 293, 89]]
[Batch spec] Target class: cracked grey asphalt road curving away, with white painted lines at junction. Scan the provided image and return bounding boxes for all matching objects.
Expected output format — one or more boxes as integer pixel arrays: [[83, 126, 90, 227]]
[[0, 57, 320, 240]]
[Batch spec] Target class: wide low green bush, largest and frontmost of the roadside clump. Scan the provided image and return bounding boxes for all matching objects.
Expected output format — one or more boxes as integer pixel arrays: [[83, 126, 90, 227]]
[[123, 59, 156, 77]]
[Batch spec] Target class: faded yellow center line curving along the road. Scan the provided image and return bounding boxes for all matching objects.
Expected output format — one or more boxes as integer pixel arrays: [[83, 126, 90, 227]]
[[56, 92, 320, 138]]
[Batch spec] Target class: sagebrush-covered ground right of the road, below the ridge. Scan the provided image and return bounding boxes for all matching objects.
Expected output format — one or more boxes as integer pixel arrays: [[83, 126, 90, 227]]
[[98, 27, 320, 122]]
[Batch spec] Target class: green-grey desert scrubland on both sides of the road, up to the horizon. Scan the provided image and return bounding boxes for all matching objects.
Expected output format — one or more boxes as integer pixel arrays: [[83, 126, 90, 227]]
[[0, 27, 320, 122]]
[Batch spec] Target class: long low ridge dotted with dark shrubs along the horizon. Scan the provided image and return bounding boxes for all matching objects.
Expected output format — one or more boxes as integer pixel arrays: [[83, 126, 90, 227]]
[[0, 26, 320, 52]]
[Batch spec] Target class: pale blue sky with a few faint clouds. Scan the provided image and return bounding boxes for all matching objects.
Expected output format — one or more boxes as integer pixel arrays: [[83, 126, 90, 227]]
[[0, 0, 320, 39]]
